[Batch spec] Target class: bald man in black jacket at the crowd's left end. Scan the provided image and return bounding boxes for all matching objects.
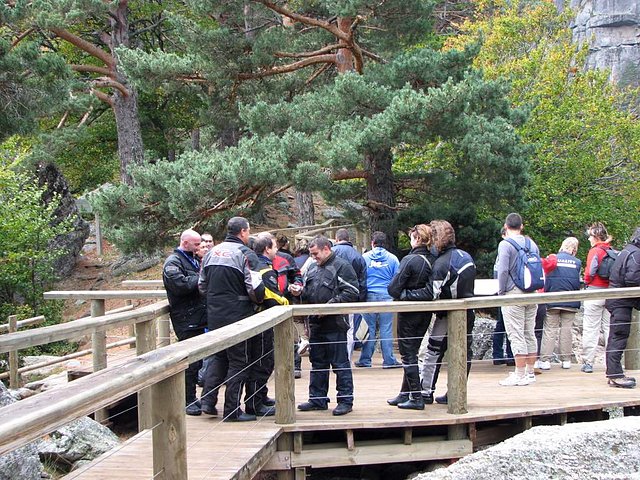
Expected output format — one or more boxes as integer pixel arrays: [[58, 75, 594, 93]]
[[162, 230, 207, 415]]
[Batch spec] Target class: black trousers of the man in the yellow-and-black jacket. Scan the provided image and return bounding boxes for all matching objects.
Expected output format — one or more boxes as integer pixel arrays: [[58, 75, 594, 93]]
[[244, 328, 274, 412]]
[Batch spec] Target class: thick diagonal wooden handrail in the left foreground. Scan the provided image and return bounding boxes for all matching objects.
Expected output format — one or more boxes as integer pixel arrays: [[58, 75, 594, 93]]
[[0, 307, 291, 455]]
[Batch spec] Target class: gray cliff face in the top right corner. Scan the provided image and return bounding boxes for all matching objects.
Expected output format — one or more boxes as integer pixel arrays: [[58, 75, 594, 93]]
[[568, 0, 640, 86]]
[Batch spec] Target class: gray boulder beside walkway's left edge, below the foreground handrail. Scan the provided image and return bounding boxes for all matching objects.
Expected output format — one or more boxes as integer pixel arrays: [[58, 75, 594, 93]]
[[38, 417, 120, 469]]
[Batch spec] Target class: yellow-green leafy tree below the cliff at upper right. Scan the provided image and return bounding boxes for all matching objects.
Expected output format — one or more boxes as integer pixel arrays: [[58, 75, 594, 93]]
[[451, 0, 640, 253]]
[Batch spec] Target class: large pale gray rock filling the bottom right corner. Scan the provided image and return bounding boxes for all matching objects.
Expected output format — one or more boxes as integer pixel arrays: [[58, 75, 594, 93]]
[[416, 417, 640, 480]]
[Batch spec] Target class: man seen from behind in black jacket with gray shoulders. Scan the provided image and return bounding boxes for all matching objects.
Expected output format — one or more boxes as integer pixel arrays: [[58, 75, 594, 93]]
[[199, 217, 264, 422]]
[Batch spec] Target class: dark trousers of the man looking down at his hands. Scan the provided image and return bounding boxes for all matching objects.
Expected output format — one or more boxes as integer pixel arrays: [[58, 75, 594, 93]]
[[309, 330, 353, 406]]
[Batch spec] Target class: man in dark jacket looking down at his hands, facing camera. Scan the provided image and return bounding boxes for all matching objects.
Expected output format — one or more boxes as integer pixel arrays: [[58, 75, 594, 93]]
[[298, 237, 360, 415]]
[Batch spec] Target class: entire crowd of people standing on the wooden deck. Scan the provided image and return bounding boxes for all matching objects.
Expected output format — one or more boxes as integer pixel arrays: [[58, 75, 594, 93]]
[[163, 213, 640, 421]]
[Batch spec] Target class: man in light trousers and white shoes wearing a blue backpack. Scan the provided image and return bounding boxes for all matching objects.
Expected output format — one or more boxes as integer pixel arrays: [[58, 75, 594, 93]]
[[497, 213, 544, 386]]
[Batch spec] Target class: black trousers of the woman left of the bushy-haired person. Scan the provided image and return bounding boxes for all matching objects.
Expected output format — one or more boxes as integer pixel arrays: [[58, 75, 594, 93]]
[[398, 312, 431, 395]]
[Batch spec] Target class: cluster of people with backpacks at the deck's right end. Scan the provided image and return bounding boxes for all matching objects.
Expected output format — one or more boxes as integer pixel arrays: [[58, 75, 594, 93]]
[[494, 213, 640, 388]]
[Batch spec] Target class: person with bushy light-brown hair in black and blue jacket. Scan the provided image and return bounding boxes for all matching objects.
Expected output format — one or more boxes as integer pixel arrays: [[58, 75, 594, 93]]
[[401, 220, 476, 408]]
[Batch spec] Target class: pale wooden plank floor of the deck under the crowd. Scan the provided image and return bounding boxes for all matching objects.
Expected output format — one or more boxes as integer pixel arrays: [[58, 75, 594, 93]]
[[65, 357, 640, 480]]
